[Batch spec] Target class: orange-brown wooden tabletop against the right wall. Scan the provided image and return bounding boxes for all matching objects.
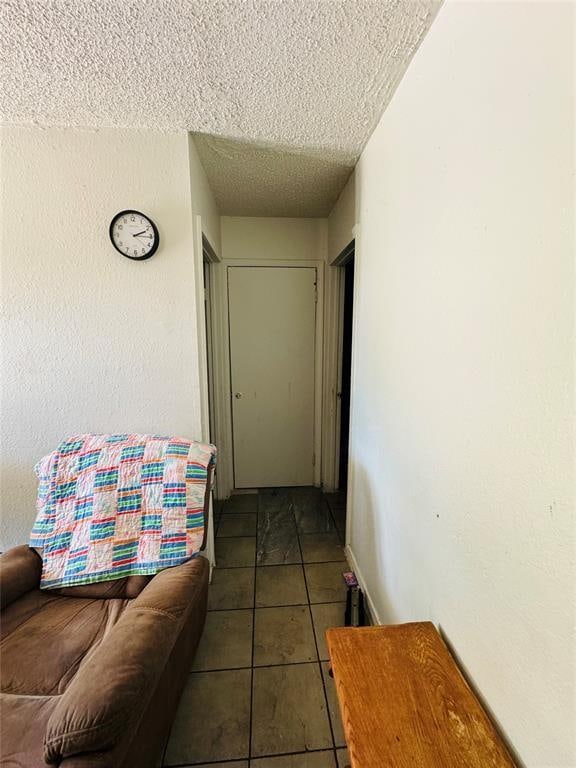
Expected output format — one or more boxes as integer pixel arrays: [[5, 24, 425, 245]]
[[326, 622, 515, 768]]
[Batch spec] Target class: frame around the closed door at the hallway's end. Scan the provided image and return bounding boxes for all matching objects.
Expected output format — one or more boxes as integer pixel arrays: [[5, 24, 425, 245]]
[[213, 258, 325, 486]]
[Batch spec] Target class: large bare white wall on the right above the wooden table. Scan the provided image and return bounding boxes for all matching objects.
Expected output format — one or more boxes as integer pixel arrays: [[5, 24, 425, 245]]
[[350, 1, 576, 768]]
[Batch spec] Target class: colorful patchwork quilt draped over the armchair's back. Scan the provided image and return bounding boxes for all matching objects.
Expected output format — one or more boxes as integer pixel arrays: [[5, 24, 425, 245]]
[[30, 434, 216, 589]]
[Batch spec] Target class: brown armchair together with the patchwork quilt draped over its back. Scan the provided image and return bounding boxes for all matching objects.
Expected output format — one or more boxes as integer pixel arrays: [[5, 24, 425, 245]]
[[0, 435, 215, 768]]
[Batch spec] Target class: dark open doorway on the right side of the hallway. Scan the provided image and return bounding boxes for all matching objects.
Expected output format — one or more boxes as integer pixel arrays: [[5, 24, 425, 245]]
[[338, 255, 354, 491]]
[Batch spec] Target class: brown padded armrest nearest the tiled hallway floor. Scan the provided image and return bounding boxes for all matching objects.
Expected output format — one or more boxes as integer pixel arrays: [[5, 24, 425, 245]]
[[44, 557, 208, 764]]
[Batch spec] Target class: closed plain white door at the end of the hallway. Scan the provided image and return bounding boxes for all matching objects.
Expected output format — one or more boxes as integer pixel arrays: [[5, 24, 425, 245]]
[[228, 267, 316, 488]]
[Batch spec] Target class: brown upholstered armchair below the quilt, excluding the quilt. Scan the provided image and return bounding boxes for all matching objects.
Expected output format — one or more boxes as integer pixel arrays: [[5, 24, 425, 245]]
[[0, 546, 209, 768]]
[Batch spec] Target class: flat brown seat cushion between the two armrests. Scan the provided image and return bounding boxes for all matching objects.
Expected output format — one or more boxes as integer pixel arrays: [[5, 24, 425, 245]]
[[0, 589, 129, 696]]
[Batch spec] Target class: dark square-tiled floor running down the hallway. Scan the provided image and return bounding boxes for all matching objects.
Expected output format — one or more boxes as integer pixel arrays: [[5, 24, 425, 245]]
[[164, 488, 348, 768]]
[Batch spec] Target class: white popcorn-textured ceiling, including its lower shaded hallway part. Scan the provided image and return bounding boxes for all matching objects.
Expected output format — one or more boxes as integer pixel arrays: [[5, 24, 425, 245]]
[[0, 0, 439, 215]]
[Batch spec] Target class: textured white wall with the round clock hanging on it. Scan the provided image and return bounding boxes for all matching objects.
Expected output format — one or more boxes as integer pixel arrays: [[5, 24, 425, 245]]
[[0, 127, 217, 548]]
